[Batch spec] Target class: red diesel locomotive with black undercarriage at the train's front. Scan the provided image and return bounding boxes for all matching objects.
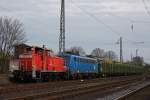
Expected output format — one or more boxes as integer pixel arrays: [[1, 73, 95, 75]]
[[11, 47, 67, 81]]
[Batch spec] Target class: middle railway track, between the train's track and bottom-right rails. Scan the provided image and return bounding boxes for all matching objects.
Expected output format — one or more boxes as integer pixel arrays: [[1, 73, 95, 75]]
[[1, 77, 142, 100]]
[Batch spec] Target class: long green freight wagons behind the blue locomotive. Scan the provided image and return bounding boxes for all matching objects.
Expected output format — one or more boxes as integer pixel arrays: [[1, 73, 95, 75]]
[[97, 60, 144, 76]]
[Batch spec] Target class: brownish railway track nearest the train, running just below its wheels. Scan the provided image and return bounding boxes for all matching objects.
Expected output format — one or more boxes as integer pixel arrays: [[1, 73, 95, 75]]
[[0, 76, 137, 94]]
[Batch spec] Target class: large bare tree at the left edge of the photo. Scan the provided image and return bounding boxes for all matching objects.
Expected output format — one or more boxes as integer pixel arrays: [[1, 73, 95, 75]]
[[0, 17, 25, 56]]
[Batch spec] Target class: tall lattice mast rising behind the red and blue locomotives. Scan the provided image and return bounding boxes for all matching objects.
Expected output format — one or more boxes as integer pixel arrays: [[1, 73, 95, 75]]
[[59, 0, 65, 53]]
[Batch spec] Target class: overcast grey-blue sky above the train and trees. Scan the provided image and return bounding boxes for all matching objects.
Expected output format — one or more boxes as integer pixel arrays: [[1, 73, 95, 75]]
[[0, 0, 150, 63]]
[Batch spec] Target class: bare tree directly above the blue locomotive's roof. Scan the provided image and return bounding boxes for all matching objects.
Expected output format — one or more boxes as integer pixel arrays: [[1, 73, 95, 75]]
[[66, 46, 86, 56]]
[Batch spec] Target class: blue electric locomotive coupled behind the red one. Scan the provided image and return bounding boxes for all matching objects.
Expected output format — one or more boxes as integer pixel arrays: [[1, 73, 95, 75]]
[[62, 54, 98, 79]]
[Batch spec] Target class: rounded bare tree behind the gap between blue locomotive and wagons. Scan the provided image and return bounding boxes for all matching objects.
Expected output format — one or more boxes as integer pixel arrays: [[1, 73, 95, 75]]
[[91, 48, 105, 58]]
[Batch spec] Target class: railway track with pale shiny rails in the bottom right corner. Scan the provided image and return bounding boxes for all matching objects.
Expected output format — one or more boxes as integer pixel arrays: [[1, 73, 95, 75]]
[[95, 77, 150, 100]]
